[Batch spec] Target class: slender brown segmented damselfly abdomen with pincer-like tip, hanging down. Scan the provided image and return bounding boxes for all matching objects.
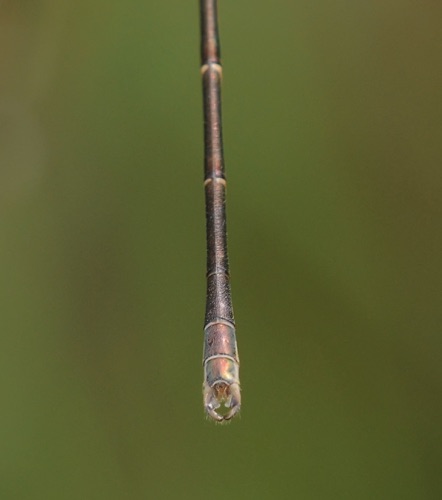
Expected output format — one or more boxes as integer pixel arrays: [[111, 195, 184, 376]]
[[200, 0, 241, 422]]
